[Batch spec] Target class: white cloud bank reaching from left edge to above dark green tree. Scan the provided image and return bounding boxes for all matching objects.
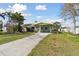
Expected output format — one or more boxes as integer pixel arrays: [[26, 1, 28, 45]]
[[0, 4, 27, 13]]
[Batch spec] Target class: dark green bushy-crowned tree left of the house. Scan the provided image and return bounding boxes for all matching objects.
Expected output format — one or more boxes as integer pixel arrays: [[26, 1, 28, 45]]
[[10, 12, 25, 32]]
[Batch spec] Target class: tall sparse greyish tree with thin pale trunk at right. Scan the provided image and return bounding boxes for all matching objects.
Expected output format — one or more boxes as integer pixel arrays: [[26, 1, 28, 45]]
[[61, 3, 78, 34]]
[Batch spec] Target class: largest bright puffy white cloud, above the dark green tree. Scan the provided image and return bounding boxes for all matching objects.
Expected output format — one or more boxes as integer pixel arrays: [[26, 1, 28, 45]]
[[8, 4, 27, 12]]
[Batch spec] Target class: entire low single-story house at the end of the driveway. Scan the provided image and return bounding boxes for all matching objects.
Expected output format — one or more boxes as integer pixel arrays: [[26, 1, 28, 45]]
[[26, 23, 53, 32]]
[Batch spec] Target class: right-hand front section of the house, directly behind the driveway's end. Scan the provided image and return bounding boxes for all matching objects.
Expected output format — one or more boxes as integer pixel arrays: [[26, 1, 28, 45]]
[[34, 23, 53, 32]]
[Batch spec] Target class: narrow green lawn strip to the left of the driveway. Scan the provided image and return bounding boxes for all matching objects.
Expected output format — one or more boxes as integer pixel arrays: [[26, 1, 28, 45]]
[[0, 32, 34, 45]]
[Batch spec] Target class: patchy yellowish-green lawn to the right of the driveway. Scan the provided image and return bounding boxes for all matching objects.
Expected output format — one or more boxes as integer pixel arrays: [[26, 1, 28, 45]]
[[29, 33, 79, 56]]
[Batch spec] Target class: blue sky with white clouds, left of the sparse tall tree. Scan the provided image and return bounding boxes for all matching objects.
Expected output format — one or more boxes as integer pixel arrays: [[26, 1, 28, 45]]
[[0, 3, 63, 23]]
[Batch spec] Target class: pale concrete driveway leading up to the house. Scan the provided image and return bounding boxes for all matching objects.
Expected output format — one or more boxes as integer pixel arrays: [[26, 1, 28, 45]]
[[0, 33, 49, 56]]
